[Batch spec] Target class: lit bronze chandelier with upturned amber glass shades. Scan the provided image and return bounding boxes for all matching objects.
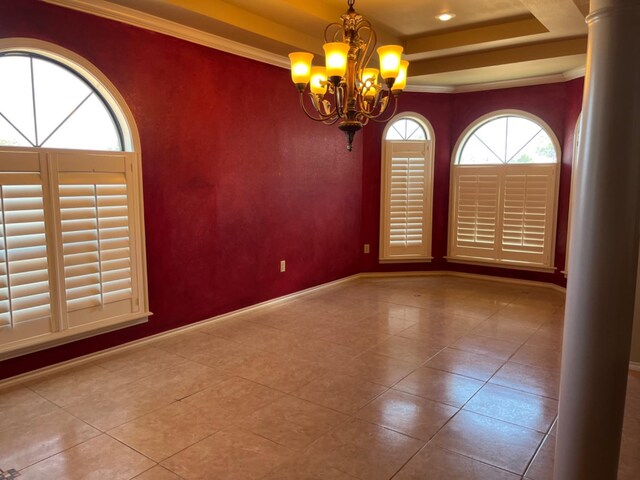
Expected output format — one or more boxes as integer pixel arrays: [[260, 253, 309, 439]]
[[289, 0, 409, 151]]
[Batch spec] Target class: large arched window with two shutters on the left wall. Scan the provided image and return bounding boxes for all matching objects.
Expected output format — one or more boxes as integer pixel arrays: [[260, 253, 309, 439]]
[[0, 39, 148, 359]]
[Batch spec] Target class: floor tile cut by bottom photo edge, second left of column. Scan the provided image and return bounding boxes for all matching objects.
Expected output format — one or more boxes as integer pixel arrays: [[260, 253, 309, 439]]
[[393, 445, 520, 480]]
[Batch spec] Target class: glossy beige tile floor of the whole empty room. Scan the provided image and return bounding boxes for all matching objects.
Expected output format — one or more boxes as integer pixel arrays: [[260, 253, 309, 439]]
[[0, 277, 640, 480]]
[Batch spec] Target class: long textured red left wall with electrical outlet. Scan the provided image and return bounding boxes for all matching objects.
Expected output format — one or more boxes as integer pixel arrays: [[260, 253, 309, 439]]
[[0, 0, 362, 378]]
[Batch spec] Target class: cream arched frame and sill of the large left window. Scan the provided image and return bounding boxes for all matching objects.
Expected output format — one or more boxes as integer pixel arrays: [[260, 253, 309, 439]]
[[0, 38, 151, 361]]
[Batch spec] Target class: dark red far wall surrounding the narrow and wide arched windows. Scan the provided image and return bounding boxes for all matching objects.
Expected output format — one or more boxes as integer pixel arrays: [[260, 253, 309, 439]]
[[362, 79, 582, 285]]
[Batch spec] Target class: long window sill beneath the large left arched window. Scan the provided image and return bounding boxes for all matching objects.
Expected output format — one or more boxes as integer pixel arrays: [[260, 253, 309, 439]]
[[0, 312, 152, 361]]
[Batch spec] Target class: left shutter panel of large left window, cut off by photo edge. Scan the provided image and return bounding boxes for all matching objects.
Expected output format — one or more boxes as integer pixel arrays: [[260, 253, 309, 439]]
[[0, 152, 53, 345]]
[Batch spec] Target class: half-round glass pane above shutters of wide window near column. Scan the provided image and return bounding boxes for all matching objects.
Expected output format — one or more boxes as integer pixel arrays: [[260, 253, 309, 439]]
[[457, 115, 557, 165]]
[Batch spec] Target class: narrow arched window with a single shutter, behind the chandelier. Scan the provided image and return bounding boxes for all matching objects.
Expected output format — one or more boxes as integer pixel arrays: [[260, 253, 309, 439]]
[[380, 113, 433, 262]]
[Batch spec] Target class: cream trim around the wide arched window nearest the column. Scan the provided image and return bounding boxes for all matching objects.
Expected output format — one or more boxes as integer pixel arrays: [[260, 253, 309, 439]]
[[445, 109, 562, 272]]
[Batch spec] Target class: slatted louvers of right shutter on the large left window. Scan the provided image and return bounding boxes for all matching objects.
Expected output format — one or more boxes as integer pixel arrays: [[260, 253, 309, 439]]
[[60, 174, 132, 312]]
